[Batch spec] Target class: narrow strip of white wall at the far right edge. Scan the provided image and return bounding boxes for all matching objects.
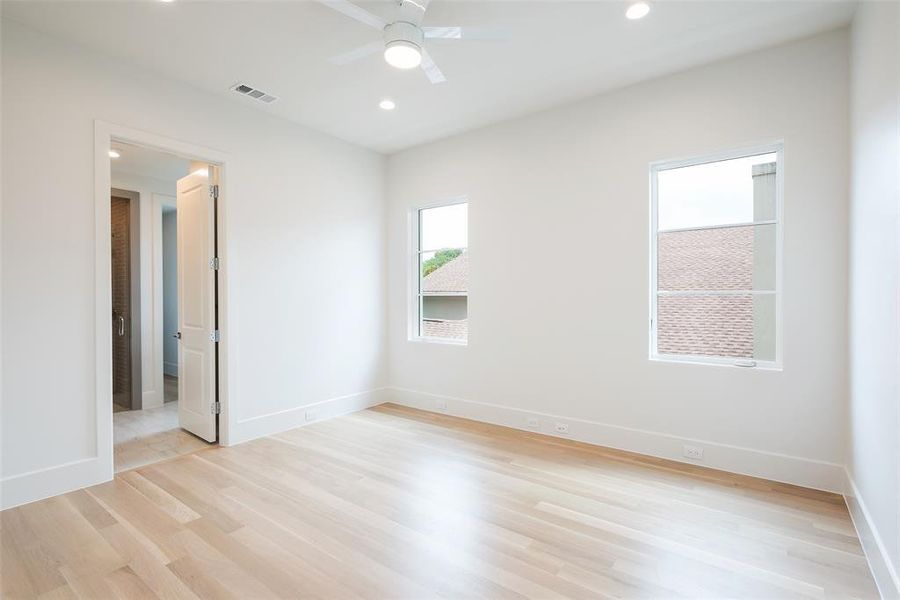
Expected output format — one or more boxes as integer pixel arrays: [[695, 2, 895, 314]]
[[848, 2, 900, 598]]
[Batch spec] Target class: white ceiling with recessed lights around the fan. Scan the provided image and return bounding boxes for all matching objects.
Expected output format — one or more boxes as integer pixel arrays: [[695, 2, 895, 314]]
[[3, 0, 855, 152]]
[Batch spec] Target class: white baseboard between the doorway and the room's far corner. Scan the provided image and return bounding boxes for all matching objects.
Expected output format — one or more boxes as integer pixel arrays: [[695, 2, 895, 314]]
[[228, 388, 385, 446]]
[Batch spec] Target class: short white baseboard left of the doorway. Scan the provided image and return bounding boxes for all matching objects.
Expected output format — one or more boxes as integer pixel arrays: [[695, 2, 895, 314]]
[[0, 457, 113, 510]]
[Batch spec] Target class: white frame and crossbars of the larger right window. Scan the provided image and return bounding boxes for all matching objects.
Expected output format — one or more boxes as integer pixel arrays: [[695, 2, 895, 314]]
[[649, 140, 784, 370]]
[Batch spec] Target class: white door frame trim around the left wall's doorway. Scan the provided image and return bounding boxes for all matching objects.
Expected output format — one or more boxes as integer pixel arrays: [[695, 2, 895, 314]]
[[94, 119, 231, 480]]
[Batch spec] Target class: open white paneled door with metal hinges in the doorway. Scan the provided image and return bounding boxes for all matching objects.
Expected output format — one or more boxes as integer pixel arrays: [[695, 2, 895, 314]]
[[176, 168, 216, 442]]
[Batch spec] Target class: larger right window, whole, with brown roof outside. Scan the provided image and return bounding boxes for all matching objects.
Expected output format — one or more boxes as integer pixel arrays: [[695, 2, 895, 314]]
[[650, 145, 782, 367]]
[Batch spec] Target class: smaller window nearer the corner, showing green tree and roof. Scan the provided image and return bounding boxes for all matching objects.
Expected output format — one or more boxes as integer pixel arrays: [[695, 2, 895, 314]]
[[413, 202, 469, 344]]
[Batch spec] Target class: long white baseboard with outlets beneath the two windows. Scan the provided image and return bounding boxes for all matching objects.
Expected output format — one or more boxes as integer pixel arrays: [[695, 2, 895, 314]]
[[385, 388, 845, 494]]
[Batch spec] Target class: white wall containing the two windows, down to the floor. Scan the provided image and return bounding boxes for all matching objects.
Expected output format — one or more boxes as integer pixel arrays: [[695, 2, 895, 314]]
[[388, 31, 849, 490]]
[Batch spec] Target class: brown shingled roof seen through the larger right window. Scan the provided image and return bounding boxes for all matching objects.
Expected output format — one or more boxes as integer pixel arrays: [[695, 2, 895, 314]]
[[657, 227, 754, 358]]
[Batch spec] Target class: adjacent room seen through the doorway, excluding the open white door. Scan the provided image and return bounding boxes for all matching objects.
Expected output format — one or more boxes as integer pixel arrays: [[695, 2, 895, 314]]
[[108, 141, 214, 472]]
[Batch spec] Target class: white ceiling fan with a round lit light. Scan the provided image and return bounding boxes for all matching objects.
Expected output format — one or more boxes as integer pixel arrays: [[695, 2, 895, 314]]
[[318, 0, 507, 83]]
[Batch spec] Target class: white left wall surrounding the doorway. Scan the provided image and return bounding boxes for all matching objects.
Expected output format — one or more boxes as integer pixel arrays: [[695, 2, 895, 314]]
[[0, 21, 385, 506]]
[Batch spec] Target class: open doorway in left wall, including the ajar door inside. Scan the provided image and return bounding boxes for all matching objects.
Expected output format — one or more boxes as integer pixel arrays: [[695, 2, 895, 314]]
[[109, 140, 219, 472]]
